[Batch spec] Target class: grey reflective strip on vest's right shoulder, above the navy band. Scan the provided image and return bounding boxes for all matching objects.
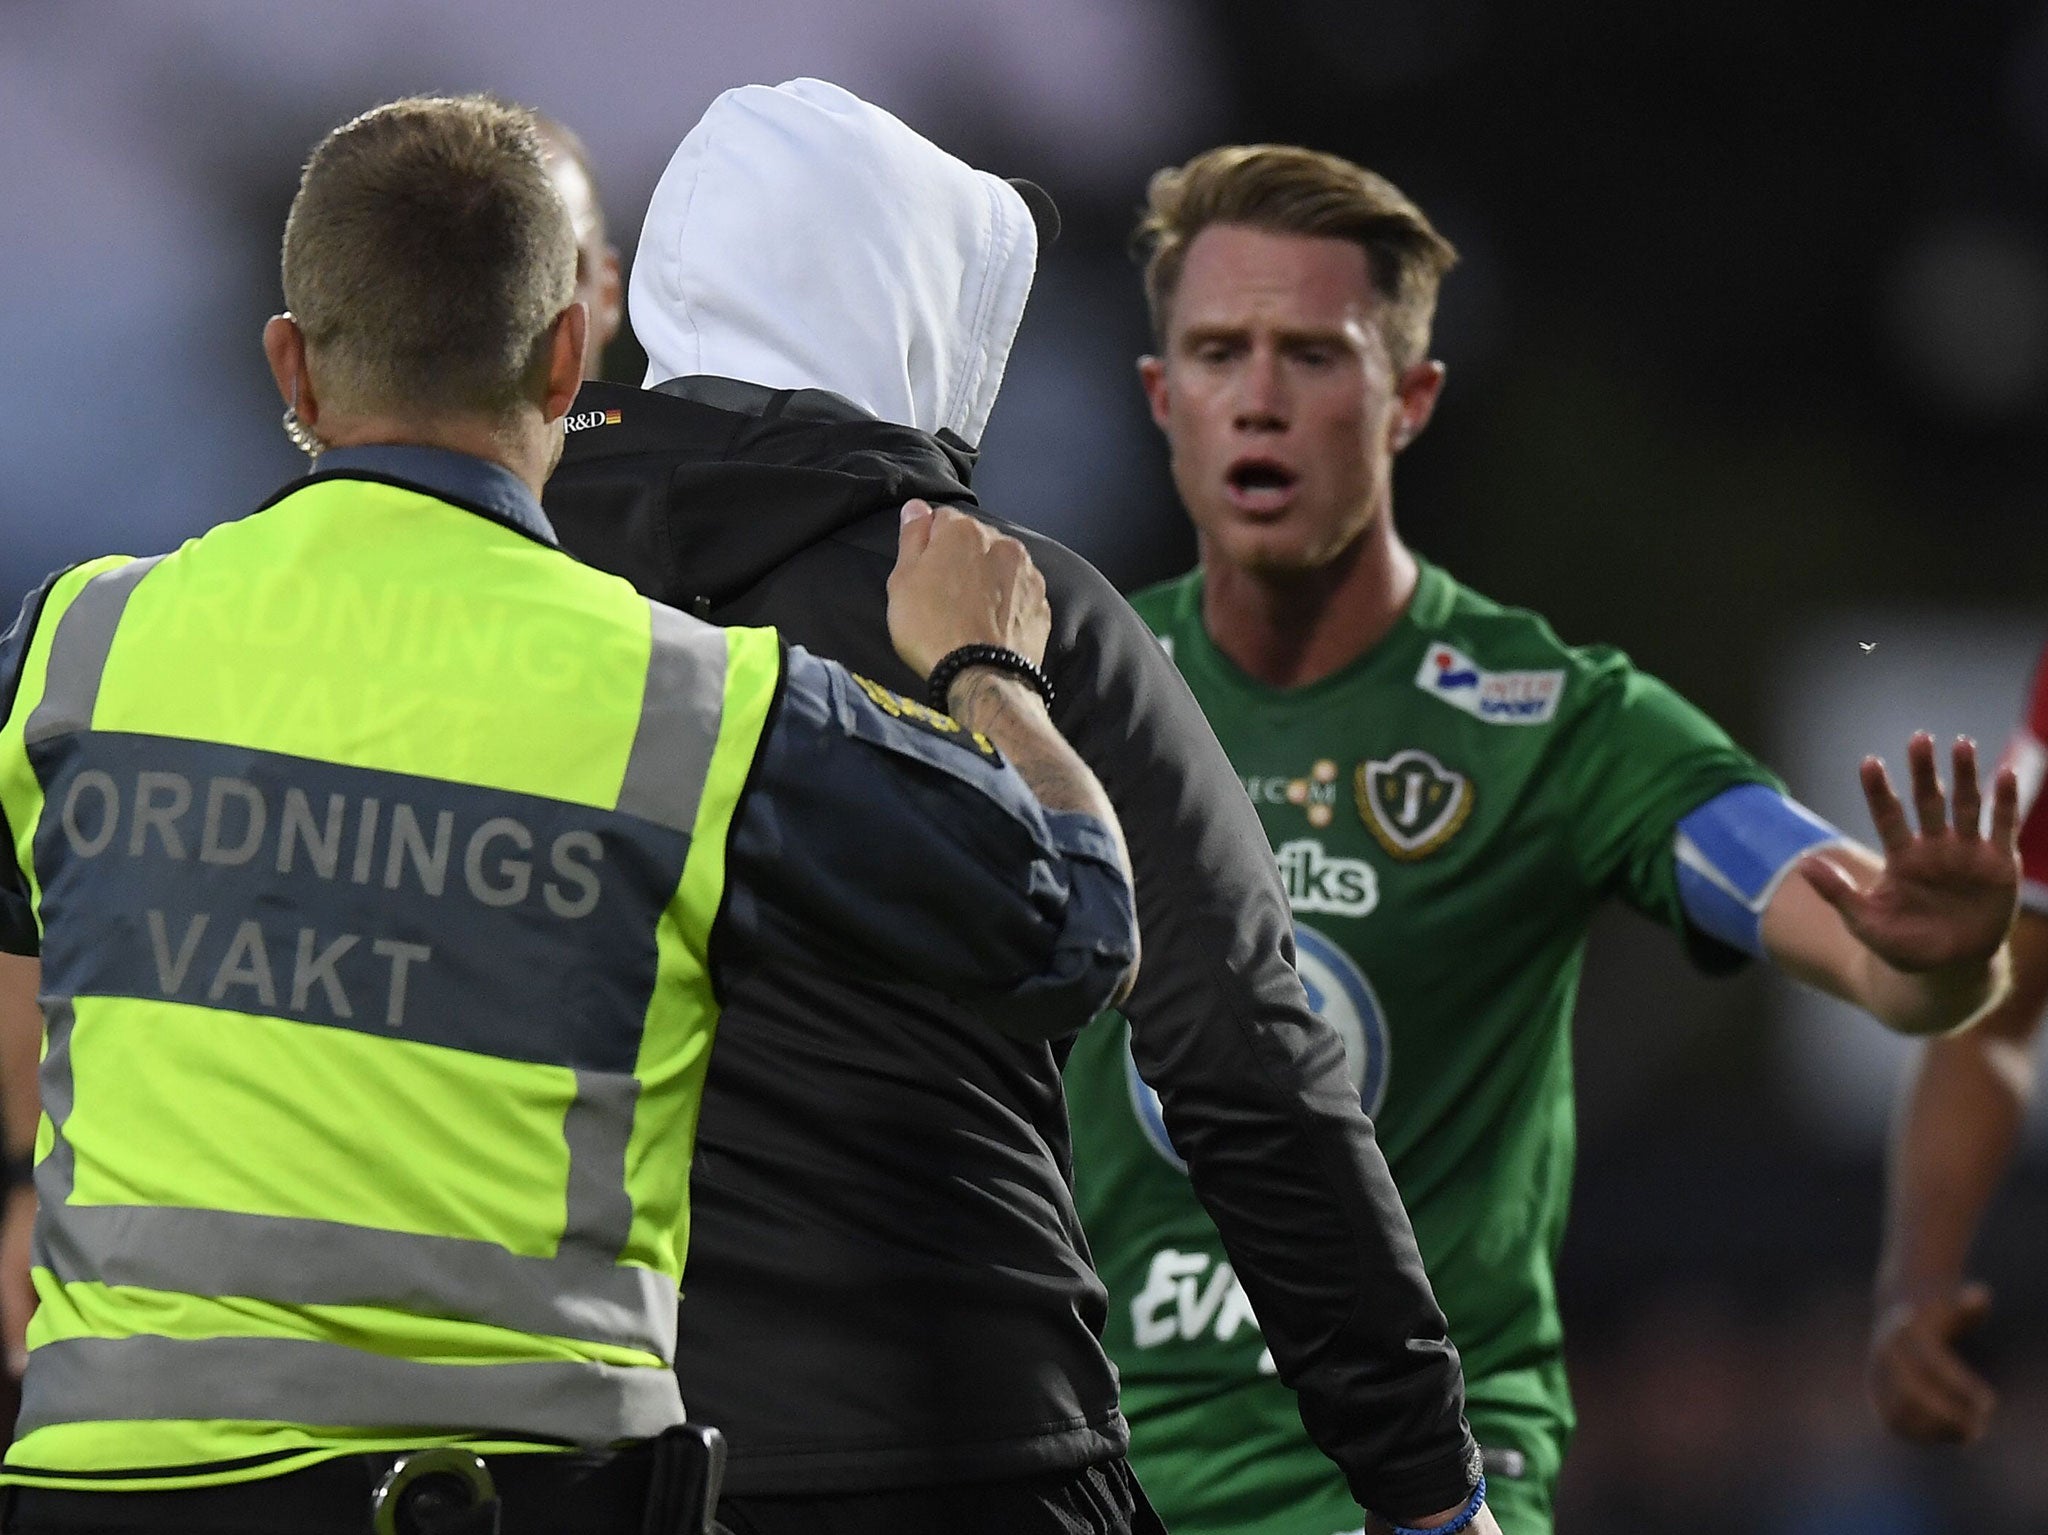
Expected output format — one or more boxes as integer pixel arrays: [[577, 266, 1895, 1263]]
[[618, 602, 725, 831]]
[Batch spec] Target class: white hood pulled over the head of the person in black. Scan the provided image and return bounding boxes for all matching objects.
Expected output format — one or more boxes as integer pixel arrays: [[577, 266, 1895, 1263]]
[[629, 80, 1038, 444]]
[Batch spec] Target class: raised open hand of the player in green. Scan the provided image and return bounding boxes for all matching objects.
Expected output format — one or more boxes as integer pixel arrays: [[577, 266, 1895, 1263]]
[[1798, 731, 2019, 974]]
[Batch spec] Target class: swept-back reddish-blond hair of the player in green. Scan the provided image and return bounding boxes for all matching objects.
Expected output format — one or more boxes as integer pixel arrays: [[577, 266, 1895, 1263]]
[[1130, 143, 1458, 368]]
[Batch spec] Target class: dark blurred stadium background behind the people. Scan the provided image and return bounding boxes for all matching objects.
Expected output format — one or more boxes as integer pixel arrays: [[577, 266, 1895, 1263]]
[[0, 0, 2048, 1535]]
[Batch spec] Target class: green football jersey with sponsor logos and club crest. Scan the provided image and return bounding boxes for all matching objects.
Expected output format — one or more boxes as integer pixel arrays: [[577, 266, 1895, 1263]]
[[1067, 565, 1776, 1535]]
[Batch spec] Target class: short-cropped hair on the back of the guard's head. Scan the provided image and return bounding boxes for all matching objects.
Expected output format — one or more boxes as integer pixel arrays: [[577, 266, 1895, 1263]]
[[285, 96, 575, 418]]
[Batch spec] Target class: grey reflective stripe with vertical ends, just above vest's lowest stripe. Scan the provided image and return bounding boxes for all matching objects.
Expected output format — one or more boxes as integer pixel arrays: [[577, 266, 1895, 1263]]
[[35, 999, 678, 1361]]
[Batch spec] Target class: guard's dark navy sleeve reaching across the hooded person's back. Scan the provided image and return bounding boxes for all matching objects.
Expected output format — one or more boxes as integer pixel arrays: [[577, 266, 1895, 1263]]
[[719, 649, 1137, 1040]]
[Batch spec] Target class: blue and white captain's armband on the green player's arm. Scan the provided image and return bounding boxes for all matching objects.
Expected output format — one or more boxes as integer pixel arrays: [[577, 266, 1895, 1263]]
[[1671, 784, 1847, 958]]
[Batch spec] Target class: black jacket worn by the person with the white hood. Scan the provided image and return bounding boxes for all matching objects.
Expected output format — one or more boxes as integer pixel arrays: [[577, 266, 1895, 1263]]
[[545, 379, 1477, 1515]]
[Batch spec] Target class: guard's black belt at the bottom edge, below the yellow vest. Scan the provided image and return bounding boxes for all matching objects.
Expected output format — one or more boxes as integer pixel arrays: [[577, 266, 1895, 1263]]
[[6, 1437, 723, 1535]]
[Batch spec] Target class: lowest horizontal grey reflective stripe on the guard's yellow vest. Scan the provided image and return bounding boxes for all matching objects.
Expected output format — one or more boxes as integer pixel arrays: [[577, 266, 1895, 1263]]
[[16, 1332, 684, 1445]]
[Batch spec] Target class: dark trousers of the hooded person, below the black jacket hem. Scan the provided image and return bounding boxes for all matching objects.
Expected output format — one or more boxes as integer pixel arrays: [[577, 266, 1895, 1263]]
[[719, 1459, 1165, 1535]]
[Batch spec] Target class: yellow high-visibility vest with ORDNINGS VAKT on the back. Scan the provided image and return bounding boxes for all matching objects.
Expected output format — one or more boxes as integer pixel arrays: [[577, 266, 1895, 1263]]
[[0, 477, 780, 1488]]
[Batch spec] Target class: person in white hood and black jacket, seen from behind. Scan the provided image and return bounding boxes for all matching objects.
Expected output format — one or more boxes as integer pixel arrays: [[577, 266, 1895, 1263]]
[[547, 80, 1491, 1535]]
